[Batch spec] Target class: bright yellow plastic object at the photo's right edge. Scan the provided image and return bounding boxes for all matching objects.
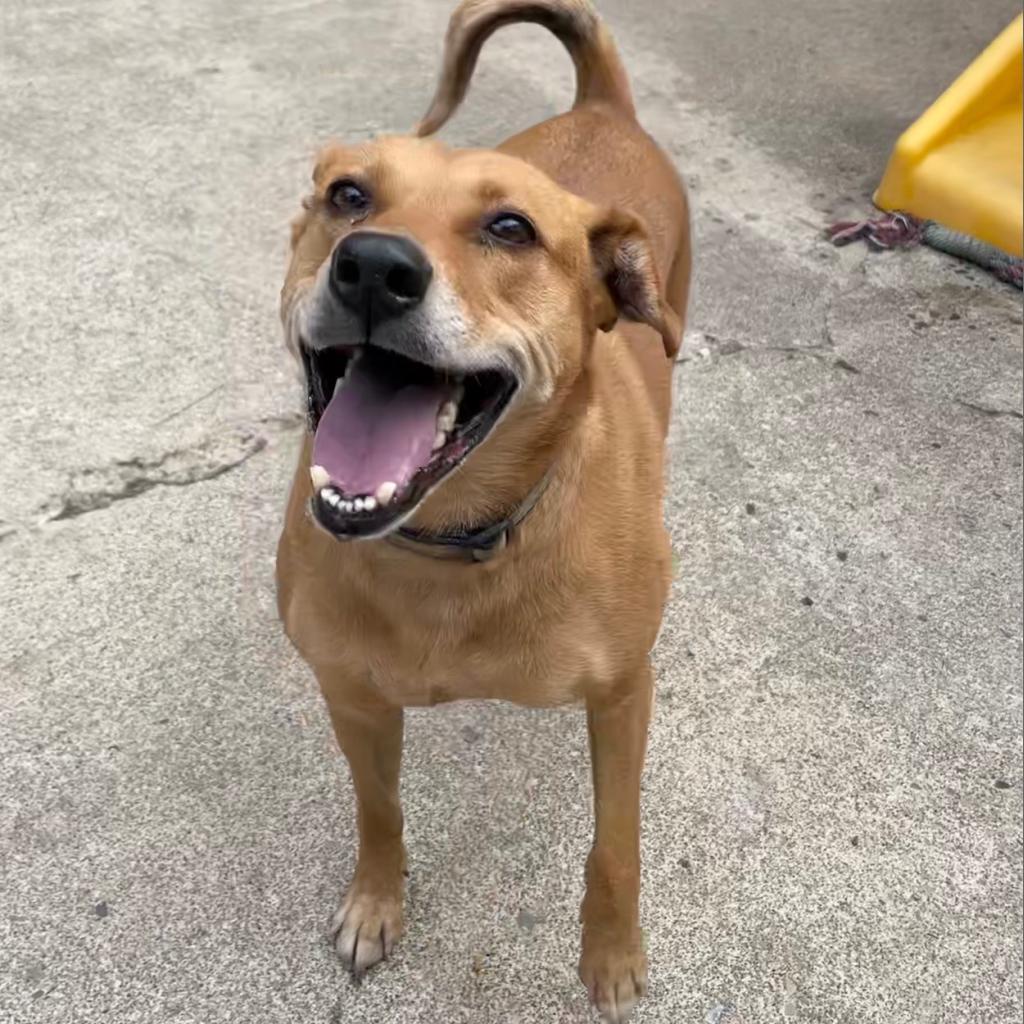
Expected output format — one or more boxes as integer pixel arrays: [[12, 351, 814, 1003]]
[[874, 15, 1024, 256]]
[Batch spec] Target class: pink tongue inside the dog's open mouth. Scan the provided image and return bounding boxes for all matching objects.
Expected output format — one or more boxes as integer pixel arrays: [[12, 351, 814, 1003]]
[[313, 359, 447, 497]]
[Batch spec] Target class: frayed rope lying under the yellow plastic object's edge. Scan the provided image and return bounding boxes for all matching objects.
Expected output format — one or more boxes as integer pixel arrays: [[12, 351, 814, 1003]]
[[827, 207, 1024, 290]]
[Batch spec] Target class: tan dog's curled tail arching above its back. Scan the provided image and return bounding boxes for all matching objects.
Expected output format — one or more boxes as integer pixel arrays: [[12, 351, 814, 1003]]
[[416, 0, 635, 135]]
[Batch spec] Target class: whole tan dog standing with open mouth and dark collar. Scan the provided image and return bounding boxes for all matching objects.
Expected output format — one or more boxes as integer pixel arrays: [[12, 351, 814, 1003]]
[[278, 0, 690, 1021]]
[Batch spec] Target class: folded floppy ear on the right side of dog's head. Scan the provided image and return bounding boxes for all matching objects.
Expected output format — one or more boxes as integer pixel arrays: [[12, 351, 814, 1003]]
[[590, 210, 683, 358]]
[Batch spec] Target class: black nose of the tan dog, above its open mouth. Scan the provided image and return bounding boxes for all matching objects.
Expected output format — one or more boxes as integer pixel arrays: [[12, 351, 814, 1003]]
[[331, 231, 433, 324]]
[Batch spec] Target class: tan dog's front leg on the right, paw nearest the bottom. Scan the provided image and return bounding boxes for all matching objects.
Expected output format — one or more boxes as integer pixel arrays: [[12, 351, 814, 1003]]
[[580, 664, 652, 1024]]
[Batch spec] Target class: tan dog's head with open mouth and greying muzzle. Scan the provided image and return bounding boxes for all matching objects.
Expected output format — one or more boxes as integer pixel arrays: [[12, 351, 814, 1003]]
[[282, 137, 678, 538]]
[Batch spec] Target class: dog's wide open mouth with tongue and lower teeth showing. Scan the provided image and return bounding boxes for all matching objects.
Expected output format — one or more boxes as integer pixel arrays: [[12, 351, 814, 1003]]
[[301, 345, 517, 538]]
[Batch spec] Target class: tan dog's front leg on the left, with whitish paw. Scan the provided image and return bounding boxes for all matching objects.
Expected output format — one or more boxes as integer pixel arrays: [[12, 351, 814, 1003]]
[[321, 678, 406, 979]]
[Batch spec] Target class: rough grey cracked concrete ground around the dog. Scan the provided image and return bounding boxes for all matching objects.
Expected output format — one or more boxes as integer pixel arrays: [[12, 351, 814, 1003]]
[[0, 0, 1022, 1024]]
